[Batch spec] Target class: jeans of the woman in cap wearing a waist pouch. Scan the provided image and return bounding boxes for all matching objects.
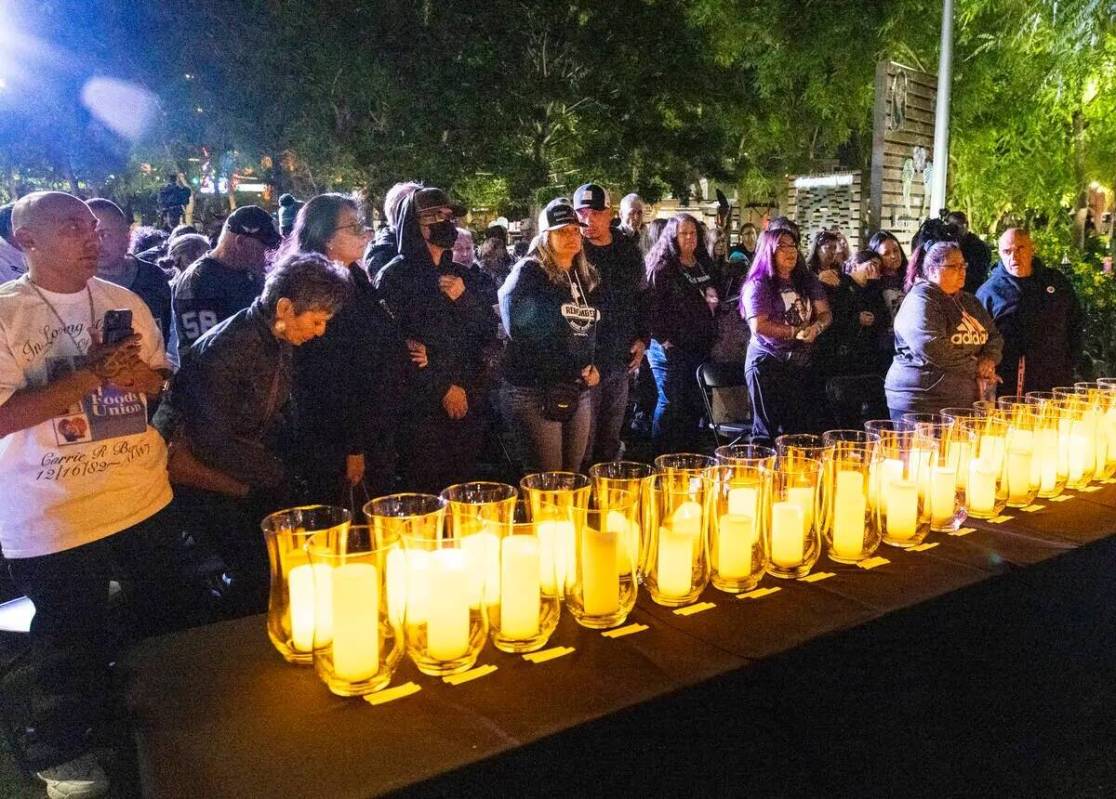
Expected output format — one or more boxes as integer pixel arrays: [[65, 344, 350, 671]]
[[500, 383, 591, 473]]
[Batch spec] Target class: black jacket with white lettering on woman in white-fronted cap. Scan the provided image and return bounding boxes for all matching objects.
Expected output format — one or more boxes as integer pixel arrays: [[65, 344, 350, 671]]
[[500, 258, 599, 388]]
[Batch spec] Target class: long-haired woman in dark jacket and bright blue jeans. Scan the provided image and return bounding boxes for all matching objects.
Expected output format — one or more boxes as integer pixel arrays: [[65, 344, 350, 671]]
[[645, 213, 719, 453]]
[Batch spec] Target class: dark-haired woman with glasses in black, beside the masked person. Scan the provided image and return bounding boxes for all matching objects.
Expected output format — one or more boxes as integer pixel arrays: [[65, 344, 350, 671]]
[[279, 194, 424, 504]]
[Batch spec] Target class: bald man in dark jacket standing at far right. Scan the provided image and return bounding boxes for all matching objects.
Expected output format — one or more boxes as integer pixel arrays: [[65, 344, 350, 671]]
[[977, 228, 1085, 394]]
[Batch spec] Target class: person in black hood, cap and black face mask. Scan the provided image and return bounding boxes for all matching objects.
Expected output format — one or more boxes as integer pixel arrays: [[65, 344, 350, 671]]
[[375, 187, 497, 493]]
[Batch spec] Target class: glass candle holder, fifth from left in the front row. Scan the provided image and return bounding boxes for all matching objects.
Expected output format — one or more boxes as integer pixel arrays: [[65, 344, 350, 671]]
[[644, 471, 710, 607]]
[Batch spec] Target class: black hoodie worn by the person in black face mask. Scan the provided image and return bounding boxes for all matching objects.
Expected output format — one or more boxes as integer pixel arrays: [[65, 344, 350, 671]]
[[375, 194, 497, 413]]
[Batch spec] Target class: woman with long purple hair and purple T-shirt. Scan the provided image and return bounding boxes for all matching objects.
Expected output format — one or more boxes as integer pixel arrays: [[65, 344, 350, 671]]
[[740, 222, 833, 445]]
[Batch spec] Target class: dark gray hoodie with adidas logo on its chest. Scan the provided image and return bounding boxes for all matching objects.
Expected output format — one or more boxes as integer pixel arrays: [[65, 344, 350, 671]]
[[884, 280, 1003, 413]]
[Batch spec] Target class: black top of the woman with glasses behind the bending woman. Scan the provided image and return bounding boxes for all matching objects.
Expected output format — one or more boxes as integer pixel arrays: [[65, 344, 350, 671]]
[[294, 264, 410, 470]]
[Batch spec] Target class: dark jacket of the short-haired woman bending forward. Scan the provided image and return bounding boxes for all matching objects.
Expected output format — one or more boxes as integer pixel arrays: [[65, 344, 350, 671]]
[[155, 300, 292, 488]]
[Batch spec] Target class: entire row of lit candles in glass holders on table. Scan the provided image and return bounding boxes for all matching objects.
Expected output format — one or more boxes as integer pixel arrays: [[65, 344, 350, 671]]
[[256, 379, 1116, 695]]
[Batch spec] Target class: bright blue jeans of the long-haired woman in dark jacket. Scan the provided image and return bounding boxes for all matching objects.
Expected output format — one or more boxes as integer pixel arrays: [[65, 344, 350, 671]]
[[647, 340, 705, 454]]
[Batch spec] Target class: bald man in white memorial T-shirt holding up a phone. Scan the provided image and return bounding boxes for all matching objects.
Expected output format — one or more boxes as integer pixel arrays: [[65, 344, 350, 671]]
[[0, 192, 198, 797]]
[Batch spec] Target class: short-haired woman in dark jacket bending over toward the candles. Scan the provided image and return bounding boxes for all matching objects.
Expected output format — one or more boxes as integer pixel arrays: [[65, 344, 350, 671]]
[[155, 253, 350, 614]]
